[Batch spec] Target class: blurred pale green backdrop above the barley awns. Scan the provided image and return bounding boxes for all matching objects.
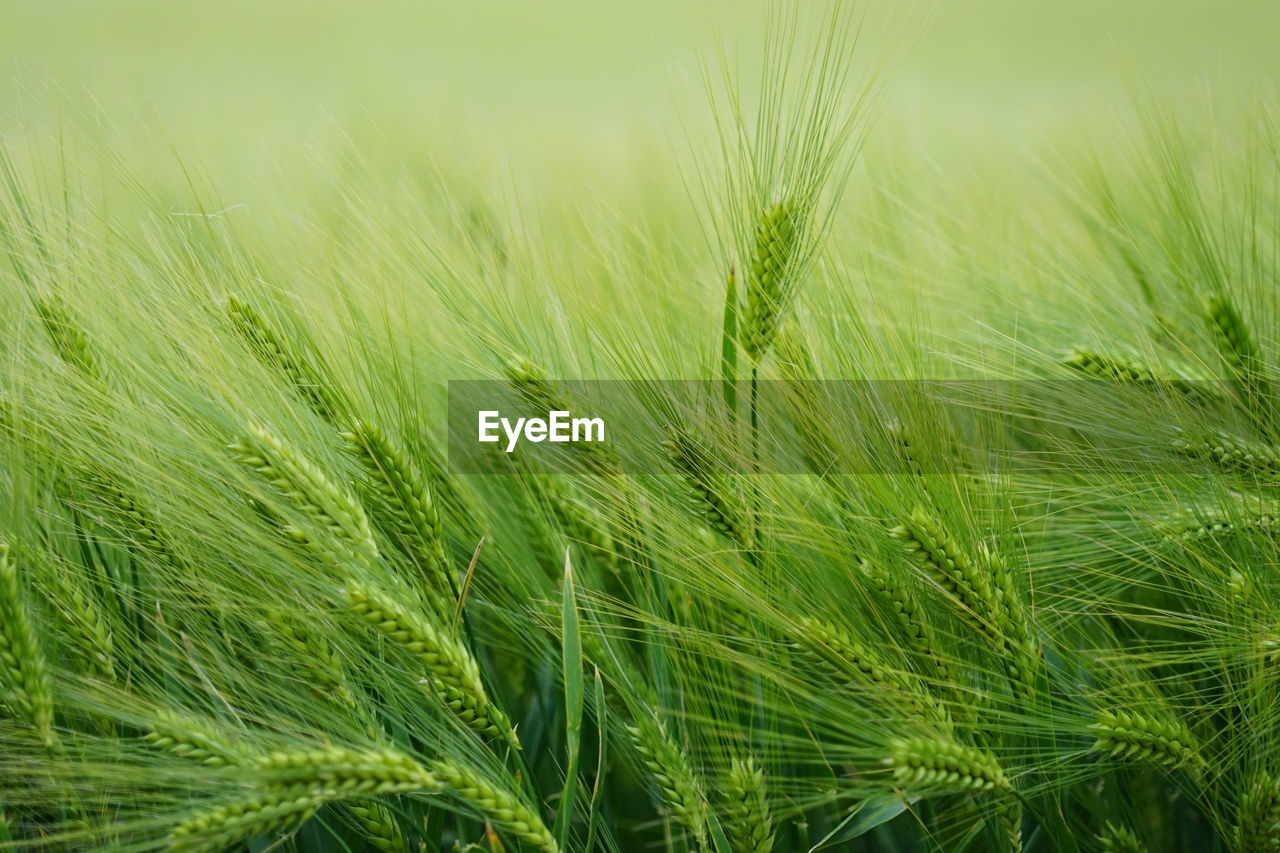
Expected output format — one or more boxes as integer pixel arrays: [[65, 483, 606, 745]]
[[0, 0, 1280, 202]]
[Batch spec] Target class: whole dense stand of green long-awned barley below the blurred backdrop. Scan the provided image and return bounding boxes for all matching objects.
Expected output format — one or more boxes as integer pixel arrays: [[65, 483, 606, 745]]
[[0, 1, 1280, 853]]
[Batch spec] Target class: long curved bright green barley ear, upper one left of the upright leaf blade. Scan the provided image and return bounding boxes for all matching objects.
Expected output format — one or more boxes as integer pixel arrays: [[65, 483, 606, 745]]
[[343, 581, 520, 749]]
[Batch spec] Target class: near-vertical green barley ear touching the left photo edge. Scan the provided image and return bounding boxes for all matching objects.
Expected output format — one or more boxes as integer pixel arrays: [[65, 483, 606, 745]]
[[0, 540, 56, 747]]
